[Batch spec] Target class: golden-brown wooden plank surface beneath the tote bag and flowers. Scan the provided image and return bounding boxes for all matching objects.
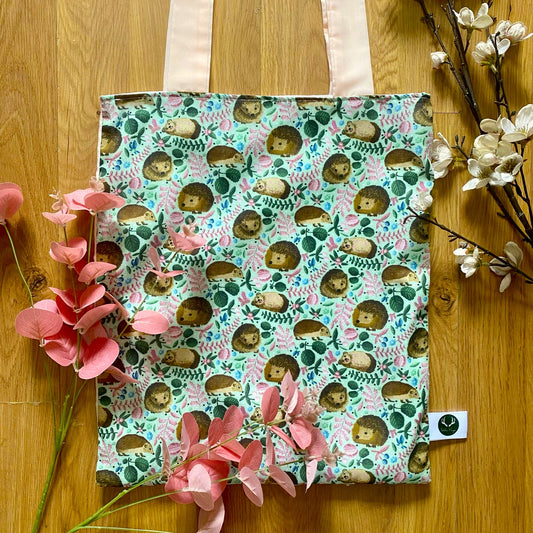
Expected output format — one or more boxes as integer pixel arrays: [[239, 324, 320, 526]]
[[0, 0, 533, 533]]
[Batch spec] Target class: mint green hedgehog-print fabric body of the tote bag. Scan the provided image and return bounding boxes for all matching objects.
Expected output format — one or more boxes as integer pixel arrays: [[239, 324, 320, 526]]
[[96, 93, 432, 486]]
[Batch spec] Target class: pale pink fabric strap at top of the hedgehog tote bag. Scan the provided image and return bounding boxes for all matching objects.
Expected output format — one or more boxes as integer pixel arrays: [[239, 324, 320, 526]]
[[163, 0, 374, 96]]
